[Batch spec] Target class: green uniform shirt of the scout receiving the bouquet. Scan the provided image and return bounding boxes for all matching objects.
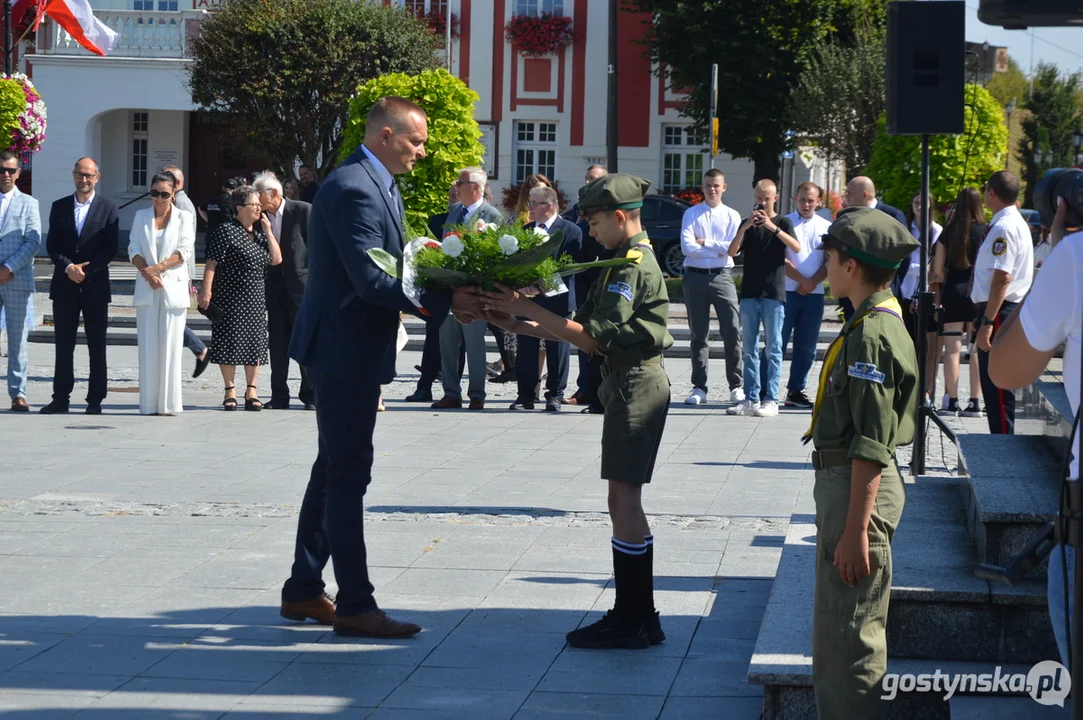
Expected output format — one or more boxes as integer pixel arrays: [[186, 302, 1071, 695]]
[[575, 233, 674, 356]]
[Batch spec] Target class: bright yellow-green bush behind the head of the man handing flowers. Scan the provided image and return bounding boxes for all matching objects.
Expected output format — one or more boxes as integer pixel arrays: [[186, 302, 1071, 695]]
[[341, 68, 485, 235]]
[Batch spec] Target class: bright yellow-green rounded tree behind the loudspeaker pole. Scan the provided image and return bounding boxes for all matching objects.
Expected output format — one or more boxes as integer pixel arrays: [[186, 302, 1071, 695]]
[[867, 84, 1008, 208]]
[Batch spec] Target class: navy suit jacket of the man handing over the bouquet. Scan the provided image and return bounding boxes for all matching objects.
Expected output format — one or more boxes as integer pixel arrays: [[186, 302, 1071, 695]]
[[289, 147, 452, 384]]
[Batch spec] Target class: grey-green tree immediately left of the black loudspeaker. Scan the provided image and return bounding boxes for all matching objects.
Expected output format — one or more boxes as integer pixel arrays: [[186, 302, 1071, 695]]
[[793, 28, 887, 174]]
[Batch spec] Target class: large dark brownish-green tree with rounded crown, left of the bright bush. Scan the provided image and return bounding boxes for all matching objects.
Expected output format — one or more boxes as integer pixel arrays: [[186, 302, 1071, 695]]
[[188, 0, 439, 176]]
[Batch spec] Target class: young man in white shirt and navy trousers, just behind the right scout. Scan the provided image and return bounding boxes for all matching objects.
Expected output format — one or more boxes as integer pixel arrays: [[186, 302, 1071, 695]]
[[782, 182, 831, 408]]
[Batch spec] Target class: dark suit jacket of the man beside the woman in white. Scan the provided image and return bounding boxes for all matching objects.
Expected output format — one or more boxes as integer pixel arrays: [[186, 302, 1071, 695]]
[[45, 194, 120, 303]]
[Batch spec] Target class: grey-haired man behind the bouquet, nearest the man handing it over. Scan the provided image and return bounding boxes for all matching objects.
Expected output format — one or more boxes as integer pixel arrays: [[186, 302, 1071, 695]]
[[432, 168, 504, 410]]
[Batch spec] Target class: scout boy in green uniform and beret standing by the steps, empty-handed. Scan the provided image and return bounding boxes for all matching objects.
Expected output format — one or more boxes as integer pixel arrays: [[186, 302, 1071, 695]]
[[805, 208, 917, 720]]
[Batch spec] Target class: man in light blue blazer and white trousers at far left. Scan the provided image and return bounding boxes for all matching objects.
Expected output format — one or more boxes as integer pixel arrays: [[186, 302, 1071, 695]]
[[0, 152, 41, 413]]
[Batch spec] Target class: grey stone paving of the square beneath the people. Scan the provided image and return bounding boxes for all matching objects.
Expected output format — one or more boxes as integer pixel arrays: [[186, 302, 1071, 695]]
[[0, 345, 992, 720]]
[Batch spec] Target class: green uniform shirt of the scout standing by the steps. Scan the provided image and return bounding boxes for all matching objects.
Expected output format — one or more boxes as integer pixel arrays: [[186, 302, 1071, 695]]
[[812, 290, 917, 467]]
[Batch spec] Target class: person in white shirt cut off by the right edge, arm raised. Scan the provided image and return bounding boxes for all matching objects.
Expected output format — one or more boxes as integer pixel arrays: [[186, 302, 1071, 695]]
[[987, 198, 1083, 665]]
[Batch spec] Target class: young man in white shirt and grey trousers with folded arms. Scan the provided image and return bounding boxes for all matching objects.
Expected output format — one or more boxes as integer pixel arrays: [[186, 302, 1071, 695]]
[[680, 169, 745, 405]]
